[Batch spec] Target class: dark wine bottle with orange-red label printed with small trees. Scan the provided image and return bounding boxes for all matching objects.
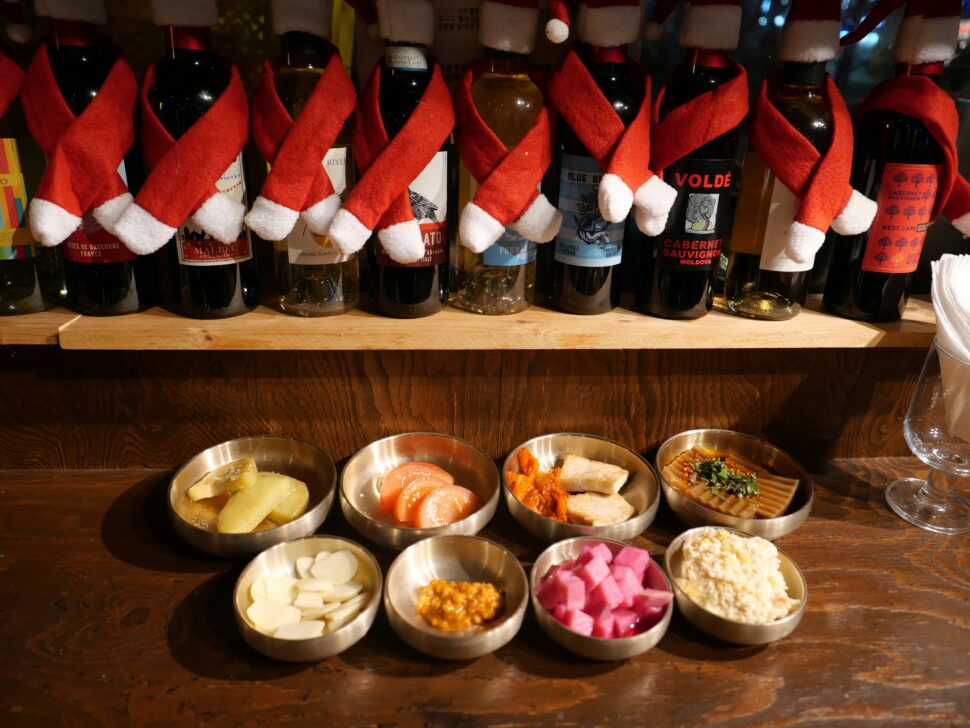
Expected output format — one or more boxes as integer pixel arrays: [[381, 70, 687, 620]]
[[822, 63, 944, 322]]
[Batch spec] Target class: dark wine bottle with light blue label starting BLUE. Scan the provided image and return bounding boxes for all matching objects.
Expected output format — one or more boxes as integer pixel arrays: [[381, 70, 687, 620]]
[[550, 47, 644, 314]]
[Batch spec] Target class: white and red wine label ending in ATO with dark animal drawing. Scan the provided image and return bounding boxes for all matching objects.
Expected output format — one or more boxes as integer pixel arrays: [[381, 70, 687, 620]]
[[377, 152, 448, 268]]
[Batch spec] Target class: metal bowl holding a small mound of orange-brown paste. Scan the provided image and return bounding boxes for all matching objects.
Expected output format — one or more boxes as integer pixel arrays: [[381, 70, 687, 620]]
[[384, 536, 529, 660]]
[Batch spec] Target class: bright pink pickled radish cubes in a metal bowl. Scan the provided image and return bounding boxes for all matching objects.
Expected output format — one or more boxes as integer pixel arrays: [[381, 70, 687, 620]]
[[536, 542, 673, 639]]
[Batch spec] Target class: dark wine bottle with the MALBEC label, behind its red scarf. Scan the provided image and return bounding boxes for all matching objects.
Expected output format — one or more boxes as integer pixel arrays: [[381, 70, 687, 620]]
[[148, 27, 259, 318]]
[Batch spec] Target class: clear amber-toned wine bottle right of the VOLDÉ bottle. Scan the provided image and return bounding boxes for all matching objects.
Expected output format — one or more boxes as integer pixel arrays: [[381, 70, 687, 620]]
[[715, 62, 833, 321]]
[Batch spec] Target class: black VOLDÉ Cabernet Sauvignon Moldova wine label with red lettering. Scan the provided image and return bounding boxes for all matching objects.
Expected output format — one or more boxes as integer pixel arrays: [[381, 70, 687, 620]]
[[657, 159, 734, 270]]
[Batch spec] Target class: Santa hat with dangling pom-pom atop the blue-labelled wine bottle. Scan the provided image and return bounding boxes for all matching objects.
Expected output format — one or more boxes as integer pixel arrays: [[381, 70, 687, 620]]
[[546, 0, 643, 48]]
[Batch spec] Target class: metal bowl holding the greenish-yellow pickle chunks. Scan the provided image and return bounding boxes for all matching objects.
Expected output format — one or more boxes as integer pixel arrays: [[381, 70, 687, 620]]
[[168, 437, 337, 557]]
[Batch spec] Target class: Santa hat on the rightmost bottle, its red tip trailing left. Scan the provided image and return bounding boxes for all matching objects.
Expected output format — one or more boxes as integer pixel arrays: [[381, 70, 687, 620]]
[[842, 0, 963, 66]]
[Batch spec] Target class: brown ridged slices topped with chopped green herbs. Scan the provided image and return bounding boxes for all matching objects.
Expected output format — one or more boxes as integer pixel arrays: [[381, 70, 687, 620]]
[[662, 447, 798, 518]]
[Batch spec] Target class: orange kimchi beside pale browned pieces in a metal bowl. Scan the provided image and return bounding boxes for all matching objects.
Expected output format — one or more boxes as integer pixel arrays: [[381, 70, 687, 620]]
[[505, 448, 637, 526]]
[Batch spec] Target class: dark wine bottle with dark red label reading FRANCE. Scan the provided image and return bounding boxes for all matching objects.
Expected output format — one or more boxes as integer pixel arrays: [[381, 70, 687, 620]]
[[47, 20, 157, 316]]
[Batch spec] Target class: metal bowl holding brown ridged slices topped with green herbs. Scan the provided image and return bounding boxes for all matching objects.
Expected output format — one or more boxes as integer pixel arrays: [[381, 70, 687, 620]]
[[654, 429, 815, 541]]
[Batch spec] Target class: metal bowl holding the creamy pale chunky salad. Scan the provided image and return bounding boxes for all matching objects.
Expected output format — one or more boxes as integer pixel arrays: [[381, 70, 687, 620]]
[[664, 526, 808, 645]]
